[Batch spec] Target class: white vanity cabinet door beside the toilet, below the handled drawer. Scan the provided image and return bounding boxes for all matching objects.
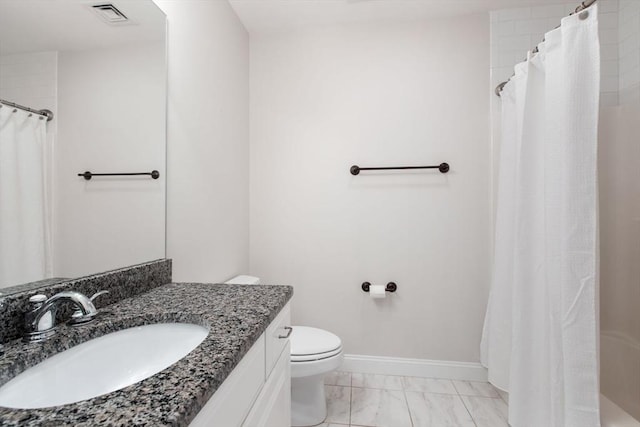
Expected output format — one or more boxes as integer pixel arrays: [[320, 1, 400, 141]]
[[243, 342, 291, 427]]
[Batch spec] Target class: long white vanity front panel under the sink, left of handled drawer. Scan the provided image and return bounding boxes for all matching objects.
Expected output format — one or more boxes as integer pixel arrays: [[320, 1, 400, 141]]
[[189, 334, 265, 427]]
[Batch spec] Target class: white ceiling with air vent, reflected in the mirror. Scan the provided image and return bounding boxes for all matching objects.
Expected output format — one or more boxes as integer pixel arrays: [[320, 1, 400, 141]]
[[0, 0, 166, 55]]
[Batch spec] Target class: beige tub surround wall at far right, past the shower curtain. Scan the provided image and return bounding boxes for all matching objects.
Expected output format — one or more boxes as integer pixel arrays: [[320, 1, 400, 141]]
[[598, 103, 640, 420]]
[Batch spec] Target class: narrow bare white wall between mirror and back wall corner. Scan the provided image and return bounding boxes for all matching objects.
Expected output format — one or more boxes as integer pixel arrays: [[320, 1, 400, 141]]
[[156, 0, 249, 282]]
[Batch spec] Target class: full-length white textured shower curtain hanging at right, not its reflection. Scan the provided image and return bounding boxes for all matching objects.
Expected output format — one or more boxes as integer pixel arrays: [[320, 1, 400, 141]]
[[481, 5, 600, 427]]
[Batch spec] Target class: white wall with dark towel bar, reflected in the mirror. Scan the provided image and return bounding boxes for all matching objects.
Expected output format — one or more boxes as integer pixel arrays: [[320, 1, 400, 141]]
[[53, 43, 166, 277]]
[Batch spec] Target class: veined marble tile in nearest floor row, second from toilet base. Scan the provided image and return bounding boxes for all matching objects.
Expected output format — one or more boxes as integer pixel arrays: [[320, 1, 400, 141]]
[[351, 387, 411, 427]]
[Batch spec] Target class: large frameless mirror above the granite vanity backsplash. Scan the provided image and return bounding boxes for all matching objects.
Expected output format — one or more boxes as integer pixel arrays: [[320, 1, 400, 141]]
[[0, 0, 167, 294]]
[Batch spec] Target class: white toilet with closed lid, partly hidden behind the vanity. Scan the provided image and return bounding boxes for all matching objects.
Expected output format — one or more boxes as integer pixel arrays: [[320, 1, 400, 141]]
[[225, 275, 342, 427]]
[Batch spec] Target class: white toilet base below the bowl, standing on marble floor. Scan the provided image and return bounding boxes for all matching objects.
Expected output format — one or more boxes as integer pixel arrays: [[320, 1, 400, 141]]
[[291, 374, 327, 427]]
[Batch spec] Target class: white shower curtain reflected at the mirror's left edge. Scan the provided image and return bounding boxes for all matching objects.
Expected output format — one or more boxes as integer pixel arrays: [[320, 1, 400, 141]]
[[0, 106, 51, 292]]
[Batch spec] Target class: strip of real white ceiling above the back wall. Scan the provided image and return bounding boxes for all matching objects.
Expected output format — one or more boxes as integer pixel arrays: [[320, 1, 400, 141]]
[[229, 0, 580, 34]]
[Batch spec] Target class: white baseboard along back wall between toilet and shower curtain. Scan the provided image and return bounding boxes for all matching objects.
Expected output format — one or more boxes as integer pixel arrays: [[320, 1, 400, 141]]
[[339, 354, 487, 381]]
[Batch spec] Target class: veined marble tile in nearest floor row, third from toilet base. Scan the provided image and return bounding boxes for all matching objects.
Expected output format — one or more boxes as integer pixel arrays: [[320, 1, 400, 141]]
[[405, 391, 475, 427]]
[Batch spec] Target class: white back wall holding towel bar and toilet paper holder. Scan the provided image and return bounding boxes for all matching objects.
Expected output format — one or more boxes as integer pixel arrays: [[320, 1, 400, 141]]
[[251, 16, 490, 361]]
